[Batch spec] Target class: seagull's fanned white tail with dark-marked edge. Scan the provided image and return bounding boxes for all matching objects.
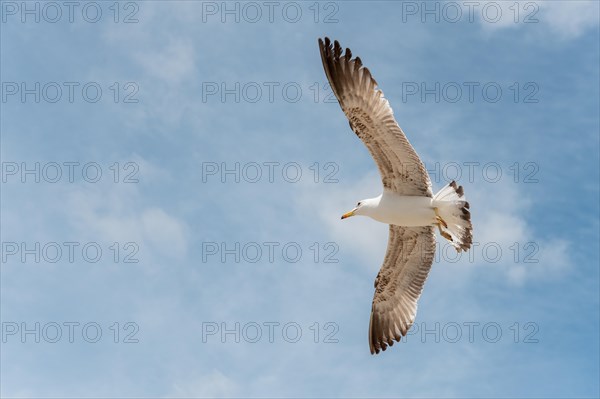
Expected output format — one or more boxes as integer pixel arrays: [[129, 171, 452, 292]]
[[433, 181, 473, 252]]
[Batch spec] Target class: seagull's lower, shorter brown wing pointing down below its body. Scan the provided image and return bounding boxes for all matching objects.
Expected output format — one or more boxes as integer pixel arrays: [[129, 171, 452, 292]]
[[369, 225, 435, 354]]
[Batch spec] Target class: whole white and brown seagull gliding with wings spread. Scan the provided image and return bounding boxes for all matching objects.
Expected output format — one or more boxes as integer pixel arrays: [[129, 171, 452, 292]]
[[319, 37, 473, 354]]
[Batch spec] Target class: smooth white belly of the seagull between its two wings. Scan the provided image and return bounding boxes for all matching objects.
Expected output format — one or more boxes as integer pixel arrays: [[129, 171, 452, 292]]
[[370, 191, 436, 227]]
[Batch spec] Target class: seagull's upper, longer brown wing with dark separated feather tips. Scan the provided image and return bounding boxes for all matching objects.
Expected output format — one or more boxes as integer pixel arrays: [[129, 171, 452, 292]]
[[319, 38, 432, 197]]
